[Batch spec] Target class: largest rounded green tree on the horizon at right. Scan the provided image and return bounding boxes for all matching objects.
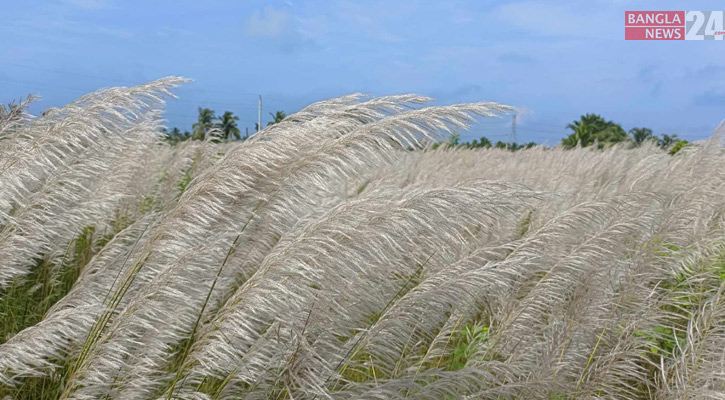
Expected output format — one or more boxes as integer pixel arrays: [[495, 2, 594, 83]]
[[561, 114, 628, 149]]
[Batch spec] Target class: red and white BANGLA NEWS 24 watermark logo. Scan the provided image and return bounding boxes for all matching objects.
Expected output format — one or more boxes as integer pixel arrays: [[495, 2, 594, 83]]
[[624, 11, 725, 40]]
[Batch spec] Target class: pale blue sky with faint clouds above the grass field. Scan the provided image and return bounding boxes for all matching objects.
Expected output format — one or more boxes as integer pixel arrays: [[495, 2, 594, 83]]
[[0, 0, 725, 144]]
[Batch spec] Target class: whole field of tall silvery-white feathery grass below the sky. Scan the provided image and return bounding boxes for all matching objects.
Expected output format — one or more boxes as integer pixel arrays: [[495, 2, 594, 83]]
[[0, 78, 725, 400]]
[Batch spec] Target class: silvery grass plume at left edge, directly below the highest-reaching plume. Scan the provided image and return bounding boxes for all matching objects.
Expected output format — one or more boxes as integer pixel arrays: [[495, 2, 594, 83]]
[[0, 116, 153, 282]]
